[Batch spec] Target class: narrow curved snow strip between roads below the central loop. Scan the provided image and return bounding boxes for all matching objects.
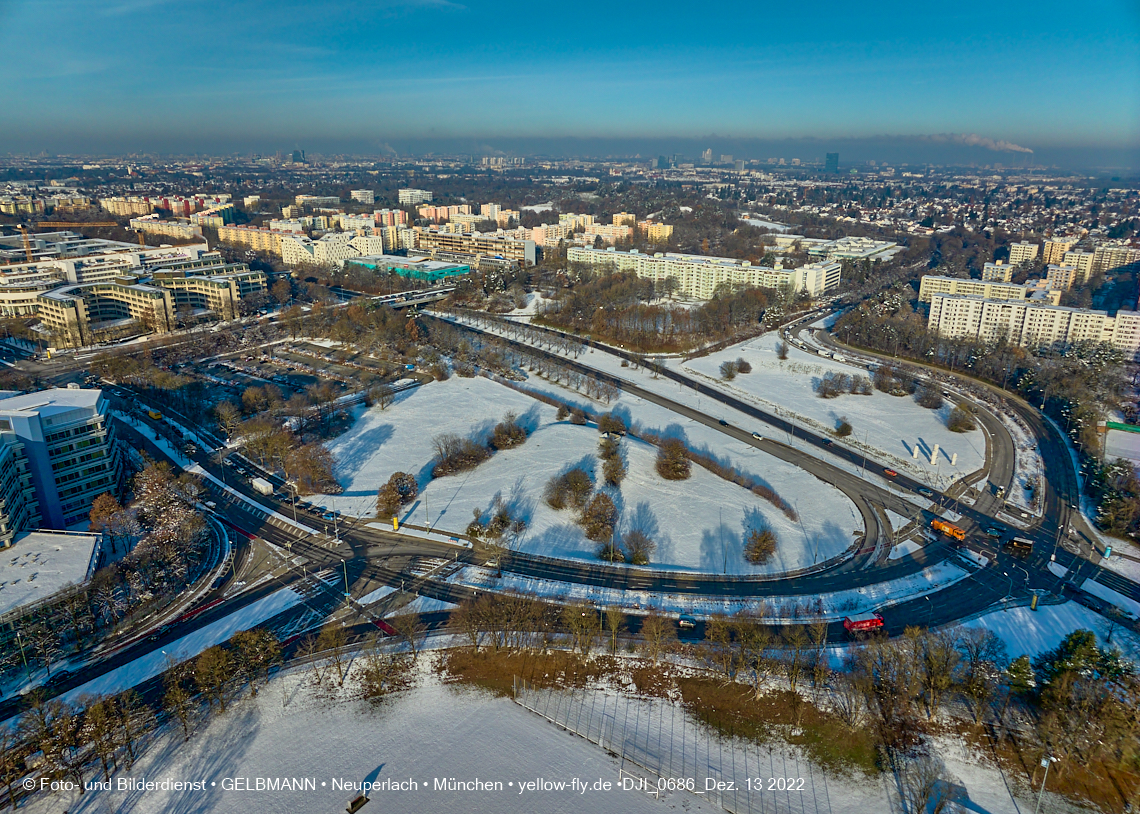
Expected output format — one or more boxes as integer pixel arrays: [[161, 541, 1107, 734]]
[[450, 562, 969, 622]]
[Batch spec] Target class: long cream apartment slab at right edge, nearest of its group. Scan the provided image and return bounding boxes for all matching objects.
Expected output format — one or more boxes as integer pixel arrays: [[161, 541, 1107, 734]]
[[927, 293, 1140, 360]]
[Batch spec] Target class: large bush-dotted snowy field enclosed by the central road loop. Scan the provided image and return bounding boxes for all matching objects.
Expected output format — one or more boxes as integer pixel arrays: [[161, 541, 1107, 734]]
[[315, 377, 862, 573]]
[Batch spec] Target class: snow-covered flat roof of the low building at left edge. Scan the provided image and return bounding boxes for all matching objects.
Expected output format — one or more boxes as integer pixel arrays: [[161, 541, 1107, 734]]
[[0, 530, 99, 613]]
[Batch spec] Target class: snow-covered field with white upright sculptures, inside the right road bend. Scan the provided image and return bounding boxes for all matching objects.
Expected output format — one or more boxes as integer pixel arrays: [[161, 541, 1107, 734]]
[[683, 332, 986, 485]]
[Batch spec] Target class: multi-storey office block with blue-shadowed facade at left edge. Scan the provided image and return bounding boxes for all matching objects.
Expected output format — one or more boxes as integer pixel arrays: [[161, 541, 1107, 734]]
[[0, 389, 123, 529]]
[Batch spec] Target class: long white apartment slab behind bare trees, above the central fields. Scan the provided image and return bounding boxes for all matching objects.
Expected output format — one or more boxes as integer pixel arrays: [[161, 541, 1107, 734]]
[[567, 246, 842, 300]]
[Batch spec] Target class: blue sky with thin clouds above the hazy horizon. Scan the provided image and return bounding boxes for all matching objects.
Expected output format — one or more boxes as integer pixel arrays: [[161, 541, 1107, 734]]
[[0, 0, 1140, 161]]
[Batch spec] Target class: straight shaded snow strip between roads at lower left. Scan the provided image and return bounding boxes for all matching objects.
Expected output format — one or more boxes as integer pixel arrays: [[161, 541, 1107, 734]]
[[60, 588, 302, 701]]
